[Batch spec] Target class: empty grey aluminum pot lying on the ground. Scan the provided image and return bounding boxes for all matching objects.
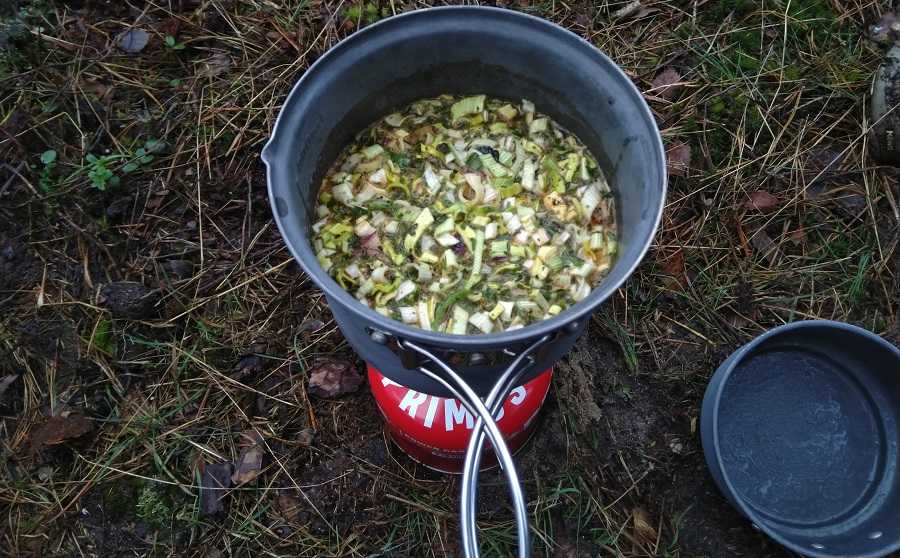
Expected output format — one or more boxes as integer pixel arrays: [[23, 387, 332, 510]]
[[700, 320, 900, 558]]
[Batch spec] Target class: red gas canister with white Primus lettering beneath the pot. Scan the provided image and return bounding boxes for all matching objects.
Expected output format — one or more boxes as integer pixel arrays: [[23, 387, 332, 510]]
[[368, 365, 553, 473]]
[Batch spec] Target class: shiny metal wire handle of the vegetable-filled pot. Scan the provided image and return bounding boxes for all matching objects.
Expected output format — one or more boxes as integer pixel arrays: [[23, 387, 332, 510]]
[[401, 335, 550, 558]]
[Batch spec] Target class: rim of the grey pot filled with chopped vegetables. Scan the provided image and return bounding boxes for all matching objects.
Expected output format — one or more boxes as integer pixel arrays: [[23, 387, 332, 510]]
[[261, 6, 668, 349]]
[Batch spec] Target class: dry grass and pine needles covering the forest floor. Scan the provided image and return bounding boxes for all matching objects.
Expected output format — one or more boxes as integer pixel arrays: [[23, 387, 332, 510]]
[[0, 0, 900, 557]]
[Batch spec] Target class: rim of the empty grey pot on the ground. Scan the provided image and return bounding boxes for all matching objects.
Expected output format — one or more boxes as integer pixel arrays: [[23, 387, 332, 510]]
[[704, 320, 900, 558]]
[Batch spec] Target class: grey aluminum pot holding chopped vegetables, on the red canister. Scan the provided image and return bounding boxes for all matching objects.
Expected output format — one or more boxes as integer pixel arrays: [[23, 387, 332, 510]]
[[262, 7, 666, 396]]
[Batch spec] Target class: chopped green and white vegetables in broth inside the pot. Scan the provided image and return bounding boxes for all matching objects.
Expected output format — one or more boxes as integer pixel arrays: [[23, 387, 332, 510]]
[[313, 95, 616, 334]]
